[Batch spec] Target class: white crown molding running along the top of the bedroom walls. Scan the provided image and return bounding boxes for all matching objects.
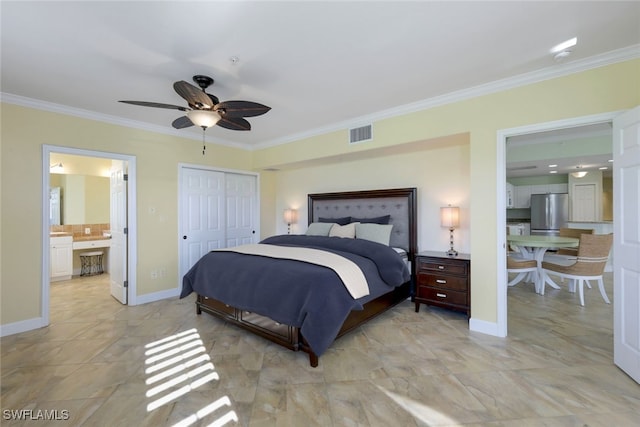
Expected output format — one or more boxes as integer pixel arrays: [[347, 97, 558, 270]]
[[0, 44, 640, 151]]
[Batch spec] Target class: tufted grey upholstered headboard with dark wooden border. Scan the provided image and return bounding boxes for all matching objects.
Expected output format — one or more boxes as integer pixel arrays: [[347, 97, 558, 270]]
[[307, 188, 417, 255]]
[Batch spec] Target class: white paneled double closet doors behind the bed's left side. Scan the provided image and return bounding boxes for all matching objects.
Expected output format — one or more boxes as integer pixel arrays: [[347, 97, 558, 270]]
[[179, 167, 258, 278]]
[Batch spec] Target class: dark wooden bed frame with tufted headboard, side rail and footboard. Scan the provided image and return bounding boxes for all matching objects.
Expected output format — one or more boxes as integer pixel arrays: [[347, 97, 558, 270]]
[[196, 188, 417, 367]]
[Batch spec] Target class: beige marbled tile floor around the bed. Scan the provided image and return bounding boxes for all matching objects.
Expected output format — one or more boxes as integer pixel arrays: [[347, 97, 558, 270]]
[[0, 275, 640, 427]]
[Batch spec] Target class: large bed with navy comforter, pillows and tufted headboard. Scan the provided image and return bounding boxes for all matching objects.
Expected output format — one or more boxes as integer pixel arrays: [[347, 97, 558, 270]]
[[180, 188, 417, 367]]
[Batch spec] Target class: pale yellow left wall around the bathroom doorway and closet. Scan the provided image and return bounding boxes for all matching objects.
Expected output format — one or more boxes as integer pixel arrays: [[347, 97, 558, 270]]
[[0, 104, 251, 325]]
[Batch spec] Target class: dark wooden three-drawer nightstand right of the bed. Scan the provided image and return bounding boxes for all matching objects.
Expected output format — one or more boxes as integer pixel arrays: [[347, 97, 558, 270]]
[[414, 251, 471, 317]]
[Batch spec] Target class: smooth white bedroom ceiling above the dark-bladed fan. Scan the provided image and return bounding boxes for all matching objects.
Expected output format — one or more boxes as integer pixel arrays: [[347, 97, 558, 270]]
[[0, 1, 640, 148]]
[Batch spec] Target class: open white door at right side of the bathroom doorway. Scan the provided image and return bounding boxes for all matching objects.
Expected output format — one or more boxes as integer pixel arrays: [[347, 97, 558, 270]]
[[109, 160, 129, 304]]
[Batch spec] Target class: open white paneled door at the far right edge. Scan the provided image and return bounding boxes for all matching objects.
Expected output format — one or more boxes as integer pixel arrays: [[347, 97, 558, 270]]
[[613, 107, 640, 383]]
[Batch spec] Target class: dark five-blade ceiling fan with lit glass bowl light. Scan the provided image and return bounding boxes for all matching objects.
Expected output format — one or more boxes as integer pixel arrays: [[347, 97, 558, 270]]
[[118, 75, 271, 130]]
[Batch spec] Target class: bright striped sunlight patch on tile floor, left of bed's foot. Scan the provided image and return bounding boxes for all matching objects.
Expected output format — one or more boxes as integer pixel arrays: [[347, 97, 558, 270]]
[[145, 329, 238, 427]]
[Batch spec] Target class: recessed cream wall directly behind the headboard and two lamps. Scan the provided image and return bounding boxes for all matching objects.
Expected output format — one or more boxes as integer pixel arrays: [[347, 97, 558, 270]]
[[268, 135, 470, 253]]
